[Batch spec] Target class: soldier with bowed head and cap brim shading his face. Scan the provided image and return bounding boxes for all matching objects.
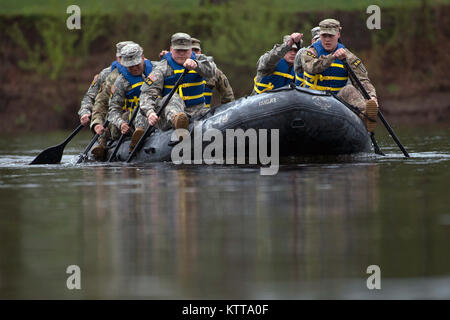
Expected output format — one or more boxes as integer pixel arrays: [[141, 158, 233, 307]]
[[108, 43, 153, 151]]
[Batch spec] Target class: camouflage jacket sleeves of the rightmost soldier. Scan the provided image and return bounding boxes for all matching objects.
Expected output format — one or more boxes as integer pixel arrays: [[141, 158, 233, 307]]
[[301, 46, 377, 98]]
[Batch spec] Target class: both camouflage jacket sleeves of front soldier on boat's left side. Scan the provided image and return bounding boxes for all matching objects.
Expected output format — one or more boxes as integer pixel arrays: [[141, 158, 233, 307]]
[[140, 54, 216, 117]]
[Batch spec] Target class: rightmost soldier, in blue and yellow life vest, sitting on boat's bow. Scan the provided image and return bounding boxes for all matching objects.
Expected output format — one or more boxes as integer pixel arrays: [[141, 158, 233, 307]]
[[301, 19, 378, 132]]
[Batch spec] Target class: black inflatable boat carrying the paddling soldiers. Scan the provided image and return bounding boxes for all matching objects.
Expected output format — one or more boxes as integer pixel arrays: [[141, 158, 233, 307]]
[[100, 87, 371, 162]]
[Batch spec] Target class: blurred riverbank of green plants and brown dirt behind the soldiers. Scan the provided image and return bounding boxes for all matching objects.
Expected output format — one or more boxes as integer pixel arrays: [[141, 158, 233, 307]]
[[0, 0, 450, 132]]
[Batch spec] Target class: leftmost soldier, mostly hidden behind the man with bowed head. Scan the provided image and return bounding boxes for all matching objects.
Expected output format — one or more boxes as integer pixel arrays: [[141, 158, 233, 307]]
[[78, 41, 131, 126]]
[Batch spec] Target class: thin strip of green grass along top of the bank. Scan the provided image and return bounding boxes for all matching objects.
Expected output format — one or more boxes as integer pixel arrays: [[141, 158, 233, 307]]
[[0, 0, 450, 15]]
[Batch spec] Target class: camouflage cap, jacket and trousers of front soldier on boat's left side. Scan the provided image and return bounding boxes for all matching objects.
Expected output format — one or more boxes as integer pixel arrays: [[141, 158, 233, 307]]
[[140, 34, 216, 130]]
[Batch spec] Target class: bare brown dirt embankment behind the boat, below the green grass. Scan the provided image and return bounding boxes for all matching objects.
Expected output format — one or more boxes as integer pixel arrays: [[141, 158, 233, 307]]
[[0, 6, 450, 132]]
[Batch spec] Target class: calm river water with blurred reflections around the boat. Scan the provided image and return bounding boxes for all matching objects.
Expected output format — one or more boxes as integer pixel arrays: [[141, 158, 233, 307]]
[[0, 125, 450, 299]]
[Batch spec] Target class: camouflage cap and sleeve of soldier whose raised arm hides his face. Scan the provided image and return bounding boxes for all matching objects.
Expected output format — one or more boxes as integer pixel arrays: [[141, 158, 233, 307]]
[[252, 36, 298, 95]]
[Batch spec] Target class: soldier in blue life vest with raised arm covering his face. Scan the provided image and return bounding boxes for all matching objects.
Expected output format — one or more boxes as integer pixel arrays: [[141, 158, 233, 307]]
[[252, 32, 303, 94]]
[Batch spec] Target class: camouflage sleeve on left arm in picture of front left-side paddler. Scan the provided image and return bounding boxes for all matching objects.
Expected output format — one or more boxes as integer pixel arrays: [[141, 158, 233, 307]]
[[139, 60, 167, 117]]
